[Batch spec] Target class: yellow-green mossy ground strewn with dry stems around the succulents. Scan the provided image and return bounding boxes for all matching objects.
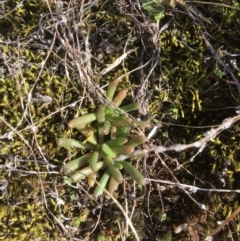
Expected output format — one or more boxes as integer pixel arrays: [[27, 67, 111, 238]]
[[0, 0, 240, 241]]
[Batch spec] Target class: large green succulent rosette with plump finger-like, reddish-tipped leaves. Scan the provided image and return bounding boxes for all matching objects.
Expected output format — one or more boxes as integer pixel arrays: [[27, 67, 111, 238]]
[[57, 80, 148, 199]]
